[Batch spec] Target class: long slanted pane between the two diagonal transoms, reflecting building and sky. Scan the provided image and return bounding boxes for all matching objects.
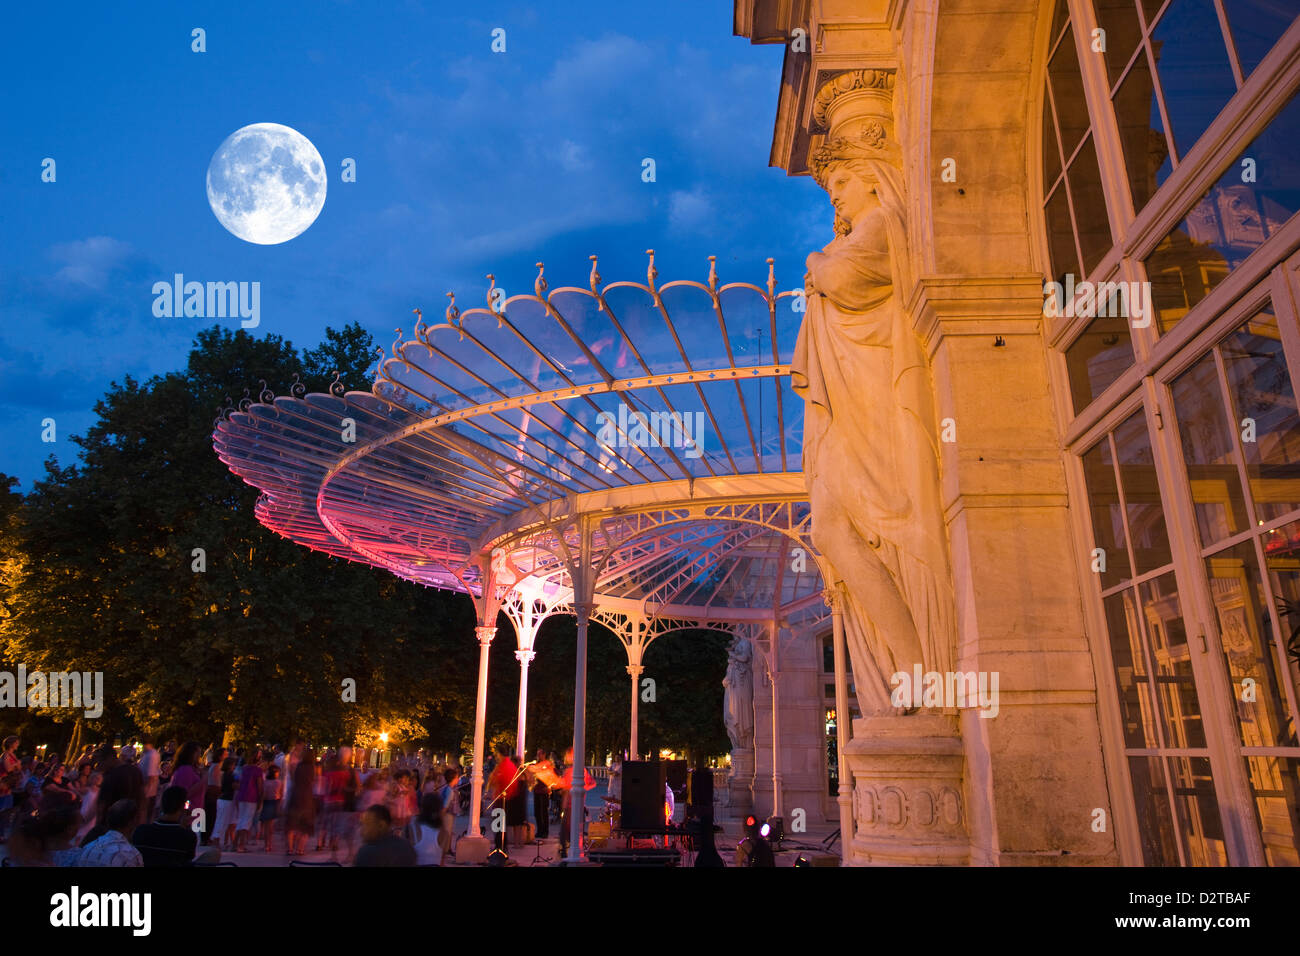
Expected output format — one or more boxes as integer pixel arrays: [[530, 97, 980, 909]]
[[1145, 98, 1300, 332]]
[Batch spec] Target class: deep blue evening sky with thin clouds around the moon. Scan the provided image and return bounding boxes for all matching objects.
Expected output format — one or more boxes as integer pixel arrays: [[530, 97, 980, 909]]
[[0, 0, 832, 489]]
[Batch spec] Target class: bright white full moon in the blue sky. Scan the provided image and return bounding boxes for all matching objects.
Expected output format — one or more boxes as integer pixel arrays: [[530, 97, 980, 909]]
[[208, 122, 325, 246]]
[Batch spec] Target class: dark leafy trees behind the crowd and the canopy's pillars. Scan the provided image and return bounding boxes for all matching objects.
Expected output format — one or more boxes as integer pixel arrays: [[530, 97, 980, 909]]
[[0, 323, 728, 753]]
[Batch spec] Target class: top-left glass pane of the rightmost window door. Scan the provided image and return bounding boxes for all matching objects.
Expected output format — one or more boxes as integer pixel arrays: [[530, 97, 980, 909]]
[[1173, 355, 1249, 546]]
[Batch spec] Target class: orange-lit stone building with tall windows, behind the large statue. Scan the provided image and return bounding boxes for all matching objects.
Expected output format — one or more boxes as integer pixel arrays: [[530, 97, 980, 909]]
[[735, 0, 1300, 866]]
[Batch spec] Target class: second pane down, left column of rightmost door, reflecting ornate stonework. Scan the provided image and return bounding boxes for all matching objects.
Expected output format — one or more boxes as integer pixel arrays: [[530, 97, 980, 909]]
[[1205, 541, 1295, 747]]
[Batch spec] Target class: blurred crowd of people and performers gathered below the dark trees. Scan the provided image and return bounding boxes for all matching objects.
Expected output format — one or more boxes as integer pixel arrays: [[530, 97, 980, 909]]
[[0, 736, 595, 866]]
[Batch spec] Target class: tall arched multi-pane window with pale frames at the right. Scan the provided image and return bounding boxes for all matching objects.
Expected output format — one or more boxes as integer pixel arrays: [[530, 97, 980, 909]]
[[1040, 0, 1300, 865]]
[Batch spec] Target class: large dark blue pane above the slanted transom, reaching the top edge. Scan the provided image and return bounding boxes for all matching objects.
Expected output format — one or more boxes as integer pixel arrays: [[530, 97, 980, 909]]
[[1151, 0, 1236, 159]]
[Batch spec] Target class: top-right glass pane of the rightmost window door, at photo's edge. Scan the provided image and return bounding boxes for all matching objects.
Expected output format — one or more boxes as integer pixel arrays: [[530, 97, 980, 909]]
[[1219, 310, 1300, 524]]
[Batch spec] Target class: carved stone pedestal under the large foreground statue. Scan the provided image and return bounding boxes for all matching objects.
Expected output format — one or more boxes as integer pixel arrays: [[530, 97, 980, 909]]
[[841, 714, 970, 866]]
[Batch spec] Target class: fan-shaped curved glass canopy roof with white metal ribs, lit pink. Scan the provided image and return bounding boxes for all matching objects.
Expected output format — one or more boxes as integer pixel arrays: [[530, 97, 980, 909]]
[[213, 254, 822, 619]]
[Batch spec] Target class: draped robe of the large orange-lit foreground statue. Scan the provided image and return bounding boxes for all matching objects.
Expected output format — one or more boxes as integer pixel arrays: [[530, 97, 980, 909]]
[[790, 197, 954, 714]]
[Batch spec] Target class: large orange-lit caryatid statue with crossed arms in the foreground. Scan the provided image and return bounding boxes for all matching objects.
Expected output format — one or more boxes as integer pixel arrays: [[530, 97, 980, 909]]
[[790, 70, 956, 715]]
